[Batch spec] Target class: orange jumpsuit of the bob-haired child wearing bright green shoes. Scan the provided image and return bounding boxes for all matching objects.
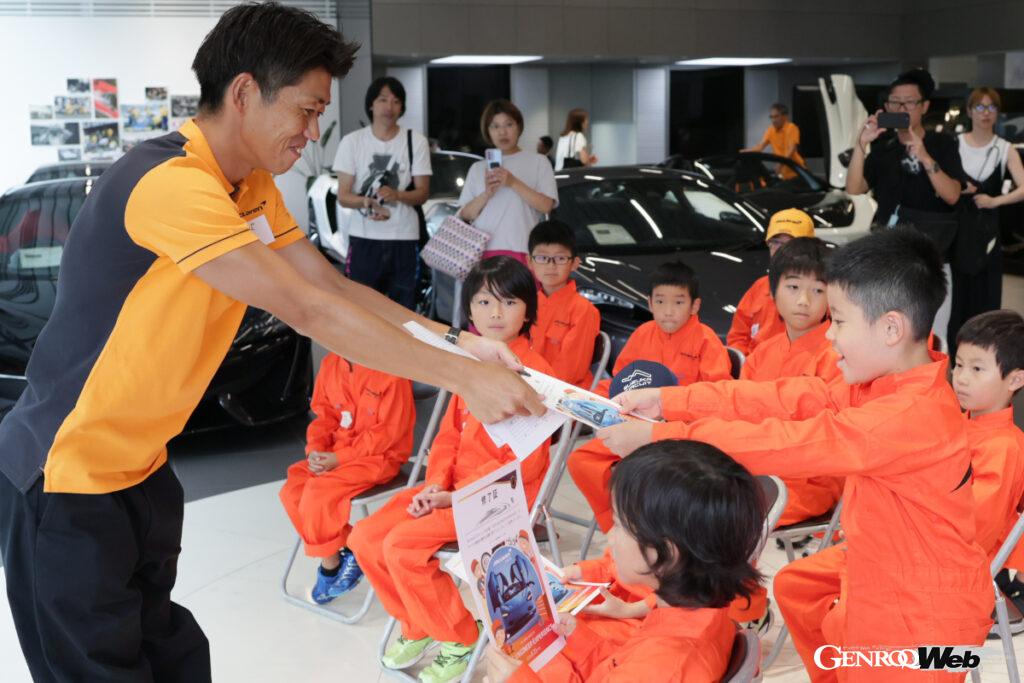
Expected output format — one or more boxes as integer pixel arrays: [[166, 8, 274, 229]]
[[348, 337, 551, 645]]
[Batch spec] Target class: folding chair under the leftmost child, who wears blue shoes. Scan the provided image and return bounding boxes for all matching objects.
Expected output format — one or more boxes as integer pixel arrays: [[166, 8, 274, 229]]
[[281, 383, 450, 624]]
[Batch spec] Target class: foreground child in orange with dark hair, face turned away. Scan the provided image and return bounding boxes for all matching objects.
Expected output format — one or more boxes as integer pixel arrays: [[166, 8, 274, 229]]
[[487, 440, 765, 683]]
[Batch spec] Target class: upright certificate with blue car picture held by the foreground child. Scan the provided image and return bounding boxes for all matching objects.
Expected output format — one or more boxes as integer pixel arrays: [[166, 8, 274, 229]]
[[452, 460, 565, 671]]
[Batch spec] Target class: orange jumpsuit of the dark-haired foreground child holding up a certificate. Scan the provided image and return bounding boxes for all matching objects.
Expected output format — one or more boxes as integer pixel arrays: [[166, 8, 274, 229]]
[[509, 607, 736, 683]]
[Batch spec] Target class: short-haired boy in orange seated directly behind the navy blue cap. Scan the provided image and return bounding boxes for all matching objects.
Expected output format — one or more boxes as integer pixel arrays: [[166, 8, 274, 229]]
[[601, 261, 732, 395]]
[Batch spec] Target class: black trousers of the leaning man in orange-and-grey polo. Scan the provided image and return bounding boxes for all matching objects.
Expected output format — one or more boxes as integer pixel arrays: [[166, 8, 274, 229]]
[[0, 465, 210, 683]]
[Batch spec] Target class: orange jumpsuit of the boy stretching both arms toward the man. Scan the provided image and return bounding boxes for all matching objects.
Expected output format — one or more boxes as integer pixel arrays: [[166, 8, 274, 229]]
[[654, 353, 993, 681]]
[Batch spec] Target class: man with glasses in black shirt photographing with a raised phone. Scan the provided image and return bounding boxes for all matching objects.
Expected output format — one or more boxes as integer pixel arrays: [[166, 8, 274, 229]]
[[846, 69, 966, 338]]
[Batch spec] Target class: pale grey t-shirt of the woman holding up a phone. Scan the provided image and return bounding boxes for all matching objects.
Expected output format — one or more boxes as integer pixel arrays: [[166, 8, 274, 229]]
[[459, 150, 558, 254]]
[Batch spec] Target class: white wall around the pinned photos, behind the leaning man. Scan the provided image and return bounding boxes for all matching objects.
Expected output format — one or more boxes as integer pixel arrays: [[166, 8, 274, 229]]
[[0, 16, 337, 225]]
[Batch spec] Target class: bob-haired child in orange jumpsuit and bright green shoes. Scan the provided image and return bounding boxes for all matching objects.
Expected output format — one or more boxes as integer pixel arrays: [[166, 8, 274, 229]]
[[349, 256, 551, 683]]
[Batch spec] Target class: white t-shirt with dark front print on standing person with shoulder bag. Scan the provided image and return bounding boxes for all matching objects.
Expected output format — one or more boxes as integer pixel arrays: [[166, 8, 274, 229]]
[[332, 126, 433, 240]]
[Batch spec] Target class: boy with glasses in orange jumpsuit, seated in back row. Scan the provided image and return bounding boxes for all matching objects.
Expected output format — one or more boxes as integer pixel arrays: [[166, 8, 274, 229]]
[[528, 220, 601, 389]]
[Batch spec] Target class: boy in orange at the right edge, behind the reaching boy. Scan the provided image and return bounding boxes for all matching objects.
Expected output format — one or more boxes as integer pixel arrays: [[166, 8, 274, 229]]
[[953, 310, 1024, 567]]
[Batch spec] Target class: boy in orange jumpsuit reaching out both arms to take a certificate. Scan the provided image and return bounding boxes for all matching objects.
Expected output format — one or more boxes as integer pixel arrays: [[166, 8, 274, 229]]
[[598, 229, 993, 681]]
